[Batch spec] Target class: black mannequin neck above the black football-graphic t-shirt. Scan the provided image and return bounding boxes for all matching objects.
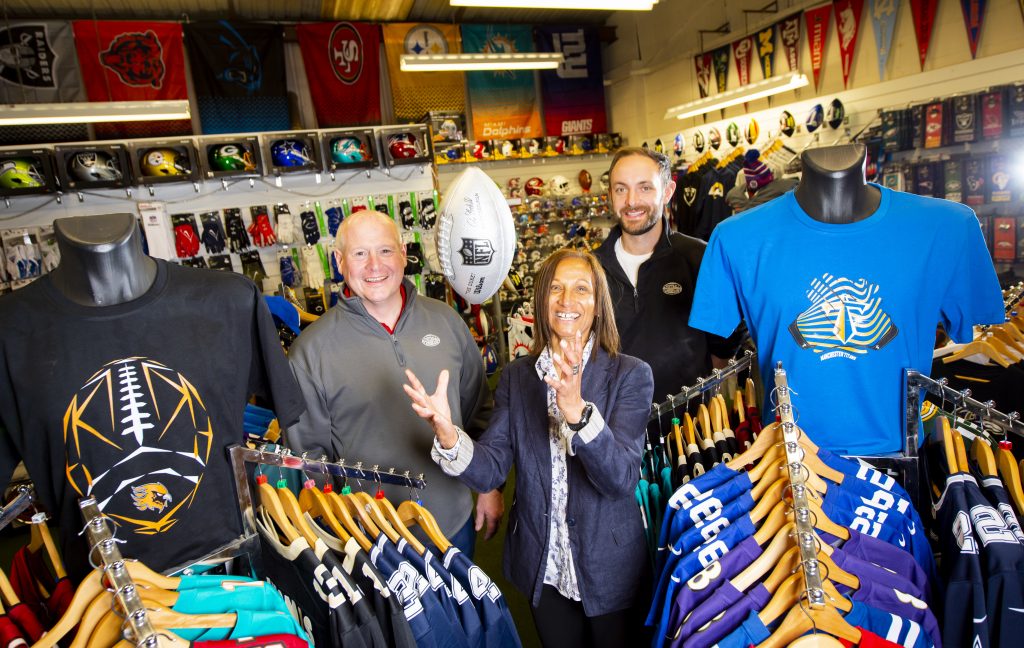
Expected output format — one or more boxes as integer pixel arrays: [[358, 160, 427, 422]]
[[48, 214, 157, 306]]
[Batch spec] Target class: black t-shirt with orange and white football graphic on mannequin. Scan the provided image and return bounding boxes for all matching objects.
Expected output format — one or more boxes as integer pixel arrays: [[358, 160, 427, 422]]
[[0, 259, 304, 578]]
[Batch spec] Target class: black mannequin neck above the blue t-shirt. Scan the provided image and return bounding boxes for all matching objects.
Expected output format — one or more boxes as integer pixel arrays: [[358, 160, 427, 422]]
[[795, 144, 882, 223]]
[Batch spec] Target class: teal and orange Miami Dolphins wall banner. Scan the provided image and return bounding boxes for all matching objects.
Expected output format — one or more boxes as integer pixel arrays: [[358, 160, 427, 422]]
[[462, 25, 544, 140]]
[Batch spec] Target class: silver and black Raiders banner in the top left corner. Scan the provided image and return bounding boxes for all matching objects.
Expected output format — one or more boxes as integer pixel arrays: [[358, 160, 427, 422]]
[[0, 20, 85, 103]]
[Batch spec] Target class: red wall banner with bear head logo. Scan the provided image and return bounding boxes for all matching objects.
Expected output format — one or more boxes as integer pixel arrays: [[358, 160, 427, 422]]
[[74, 20, 191, 137]]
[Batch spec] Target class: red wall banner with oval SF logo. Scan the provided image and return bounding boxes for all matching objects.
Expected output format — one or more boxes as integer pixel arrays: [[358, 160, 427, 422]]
[[295, 23, 382, 128]]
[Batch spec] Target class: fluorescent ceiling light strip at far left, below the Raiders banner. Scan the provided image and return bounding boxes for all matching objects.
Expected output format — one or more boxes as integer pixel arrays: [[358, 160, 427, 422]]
[[0, 99, 191, 126]]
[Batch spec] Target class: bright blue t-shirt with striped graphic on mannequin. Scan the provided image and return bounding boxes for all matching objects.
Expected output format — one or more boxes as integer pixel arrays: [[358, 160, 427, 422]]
[[689, 147, 1005, 455]]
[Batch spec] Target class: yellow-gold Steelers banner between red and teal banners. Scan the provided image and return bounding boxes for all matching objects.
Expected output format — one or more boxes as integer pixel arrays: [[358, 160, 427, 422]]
[[383, 23, 466, 122]]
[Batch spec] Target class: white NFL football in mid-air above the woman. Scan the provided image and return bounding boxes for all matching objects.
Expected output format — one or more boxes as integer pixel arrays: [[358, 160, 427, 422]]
[[436, 167, 516, 304]]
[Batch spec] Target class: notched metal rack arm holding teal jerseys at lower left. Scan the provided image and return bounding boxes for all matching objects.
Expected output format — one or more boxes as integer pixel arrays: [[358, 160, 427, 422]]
[[79, 496, 159, 648]]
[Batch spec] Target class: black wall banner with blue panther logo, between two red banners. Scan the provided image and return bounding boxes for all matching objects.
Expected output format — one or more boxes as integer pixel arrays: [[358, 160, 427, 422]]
[[184, 20, 292, 134]]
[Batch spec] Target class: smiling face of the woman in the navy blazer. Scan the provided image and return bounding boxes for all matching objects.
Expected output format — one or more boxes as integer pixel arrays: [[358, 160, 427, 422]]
[[548, 258, 596, 348]]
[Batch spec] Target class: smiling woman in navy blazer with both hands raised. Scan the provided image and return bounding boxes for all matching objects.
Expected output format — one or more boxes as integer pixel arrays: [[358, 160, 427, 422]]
[[406, 250, 654, 647]]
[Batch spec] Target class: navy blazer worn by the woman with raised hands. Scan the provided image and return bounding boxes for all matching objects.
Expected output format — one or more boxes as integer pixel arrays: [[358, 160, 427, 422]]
[[459, 346, 654, 616]]
